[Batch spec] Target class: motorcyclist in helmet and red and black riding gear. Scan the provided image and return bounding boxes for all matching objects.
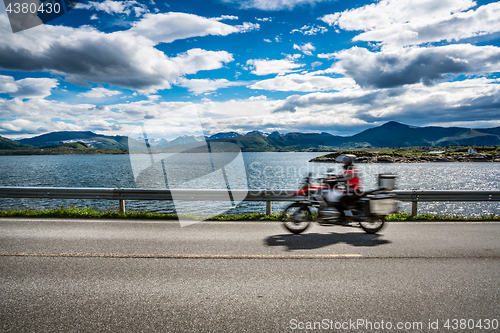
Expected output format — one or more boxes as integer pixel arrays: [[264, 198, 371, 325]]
[[335, 154, 363, 220]]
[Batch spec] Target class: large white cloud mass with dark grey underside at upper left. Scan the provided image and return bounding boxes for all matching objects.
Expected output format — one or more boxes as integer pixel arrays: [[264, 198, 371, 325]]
[[0, 14, 242, 92]]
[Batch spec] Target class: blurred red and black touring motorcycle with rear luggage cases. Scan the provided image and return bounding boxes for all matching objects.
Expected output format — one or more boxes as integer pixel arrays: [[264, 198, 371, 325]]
[[282, 174, 398, 234]]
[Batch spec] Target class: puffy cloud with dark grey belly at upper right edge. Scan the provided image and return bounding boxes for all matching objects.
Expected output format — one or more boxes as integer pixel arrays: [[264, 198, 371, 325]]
[[331, 44, 500, 88]]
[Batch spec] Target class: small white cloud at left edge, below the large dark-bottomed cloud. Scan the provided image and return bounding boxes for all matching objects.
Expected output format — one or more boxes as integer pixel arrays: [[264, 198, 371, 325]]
[[0, 75, 59, 98]]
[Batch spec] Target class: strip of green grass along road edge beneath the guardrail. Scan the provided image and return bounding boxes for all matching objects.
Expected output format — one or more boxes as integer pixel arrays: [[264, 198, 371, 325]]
[[0, 207, 500, 221]]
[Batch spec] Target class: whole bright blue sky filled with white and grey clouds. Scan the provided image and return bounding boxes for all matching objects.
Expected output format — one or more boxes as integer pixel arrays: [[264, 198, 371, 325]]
[[0, 0, 500, 138]]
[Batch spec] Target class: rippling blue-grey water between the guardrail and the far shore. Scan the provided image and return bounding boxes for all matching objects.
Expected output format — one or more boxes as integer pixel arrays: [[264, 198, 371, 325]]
[[0, 153, 500, 216]]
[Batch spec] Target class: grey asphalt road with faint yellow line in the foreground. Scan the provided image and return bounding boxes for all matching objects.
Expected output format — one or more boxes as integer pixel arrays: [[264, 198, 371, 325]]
[[0, 219, 500, 332]]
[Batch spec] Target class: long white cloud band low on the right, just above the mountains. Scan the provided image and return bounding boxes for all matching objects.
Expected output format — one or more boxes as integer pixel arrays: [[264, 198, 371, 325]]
[[275, 79, 500, 124]]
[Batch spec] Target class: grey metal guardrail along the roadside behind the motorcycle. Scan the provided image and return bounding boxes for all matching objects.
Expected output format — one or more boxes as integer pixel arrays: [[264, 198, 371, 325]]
[[0, 187, 500, 215]]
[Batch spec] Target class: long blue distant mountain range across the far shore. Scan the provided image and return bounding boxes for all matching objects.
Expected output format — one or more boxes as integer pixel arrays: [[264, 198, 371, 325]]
[[0, 121, 500, 151]]
